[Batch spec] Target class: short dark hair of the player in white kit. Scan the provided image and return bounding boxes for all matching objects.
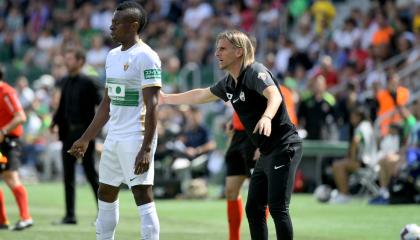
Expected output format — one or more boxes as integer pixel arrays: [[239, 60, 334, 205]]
[[116, 1, 147, 34]]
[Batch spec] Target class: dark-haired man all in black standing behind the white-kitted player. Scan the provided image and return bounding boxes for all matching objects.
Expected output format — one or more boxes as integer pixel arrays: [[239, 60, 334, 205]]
[[51, 49, 101, 224]]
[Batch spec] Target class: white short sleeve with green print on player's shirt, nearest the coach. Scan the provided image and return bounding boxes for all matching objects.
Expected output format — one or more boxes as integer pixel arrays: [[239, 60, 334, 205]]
[[140, 54, 162, 89]]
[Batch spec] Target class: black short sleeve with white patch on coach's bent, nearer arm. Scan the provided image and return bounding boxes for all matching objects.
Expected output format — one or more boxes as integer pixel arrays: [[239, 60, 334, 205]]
[[246, 64, 277, 95]]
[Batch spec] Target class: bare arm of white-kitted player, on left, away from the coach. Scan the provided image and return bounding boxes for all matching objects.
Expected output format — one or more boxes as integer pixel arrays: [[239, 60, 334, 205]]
[[67, 88, 111, 158]]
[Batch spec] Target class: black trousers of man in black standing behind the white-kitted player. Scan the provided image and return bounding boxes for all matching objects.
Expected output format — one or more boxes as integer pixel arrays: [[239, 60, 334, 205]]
[[61, 128, 99, 218]]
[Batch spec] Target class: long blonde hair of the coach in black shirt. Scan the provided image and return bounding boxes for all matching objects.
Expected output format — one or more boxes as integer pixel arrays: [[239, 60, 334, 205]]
[[216, 30, 255, 68]]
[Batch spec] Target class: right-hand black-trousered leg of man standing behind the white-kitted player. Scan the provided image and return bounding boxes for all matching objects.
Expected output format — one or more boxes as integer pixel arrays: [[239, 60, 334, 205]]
[[82, 141, 99, 206]]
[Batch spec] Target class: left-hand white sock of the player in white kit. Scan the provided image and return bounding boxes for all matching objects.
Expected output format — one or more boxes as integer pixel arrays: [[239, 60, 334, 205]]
[[96, 199, 120, 240]]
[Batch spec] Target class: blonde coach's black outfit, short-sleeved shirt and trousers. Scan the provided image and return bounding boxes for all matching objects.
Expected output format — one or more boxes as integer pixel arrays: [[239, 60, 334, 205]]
[[210, 62, 302, 240]]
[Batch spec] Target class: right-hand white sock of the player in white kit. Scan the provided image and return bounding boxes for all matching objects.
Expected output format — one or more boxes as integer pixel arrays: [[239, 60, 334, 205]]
[[138, 202, 160, 240]]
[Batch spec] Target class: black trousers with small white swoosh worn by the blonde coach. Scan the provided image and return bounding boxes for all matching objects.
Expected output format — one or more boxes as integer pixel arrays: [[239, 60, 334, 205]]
[[246, 143, 302, 240]]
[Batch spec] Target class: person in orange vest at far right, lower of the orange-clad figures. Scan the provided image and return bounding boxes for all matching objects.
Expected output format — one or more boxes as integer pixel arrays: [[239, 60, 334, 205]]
[[376, 73, 410, 136]]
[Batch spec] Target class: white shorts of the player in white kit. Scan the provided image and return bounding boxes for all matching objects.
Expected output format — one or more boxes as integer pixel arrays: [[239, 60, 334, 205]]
[[99, 137, 157, 188]]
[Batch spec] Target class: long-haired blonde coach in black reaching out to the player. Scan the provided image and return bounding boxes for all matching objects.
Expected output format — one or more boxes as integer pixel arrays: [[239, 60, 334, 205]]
[[160, 30, 302, 239]]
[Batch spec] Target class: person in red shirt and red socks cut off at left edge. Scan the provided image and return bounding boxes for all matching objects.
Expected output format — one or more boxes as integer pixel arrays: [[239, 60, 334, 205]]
[[0, 68, 33, 230]]
